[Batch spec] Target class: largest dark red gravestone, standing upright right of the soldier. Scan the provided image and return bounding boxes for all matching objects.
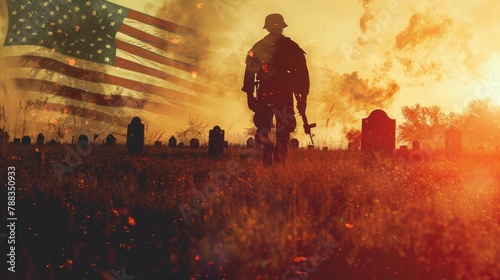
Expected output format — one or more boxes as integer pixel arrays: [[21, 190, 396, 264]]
[[361, 109, 396, 160]]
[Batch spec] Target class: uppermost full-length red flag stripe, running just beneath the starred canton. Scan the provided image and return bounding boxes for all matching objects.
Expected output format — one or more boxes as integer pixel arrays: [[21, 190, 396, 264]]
[[4, 55, 201, 102]]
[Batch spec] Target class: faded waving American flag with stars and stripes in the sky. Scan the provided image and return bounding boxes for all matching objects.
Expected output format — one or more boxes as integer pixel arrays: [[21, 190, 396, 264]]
[[0, 0, 211, 130]]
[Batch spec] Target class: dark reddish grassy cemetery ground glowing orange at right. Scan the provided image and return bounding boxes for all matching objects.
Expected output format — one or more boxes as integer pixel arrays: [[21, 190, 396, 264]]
[[0, 145, 500, 280]]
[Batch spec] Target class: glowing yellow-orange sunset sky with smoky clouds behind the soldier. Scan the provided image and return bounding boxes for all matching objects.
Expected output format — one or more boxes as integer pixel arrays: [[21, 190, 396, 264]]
[[0, 0, 500, 146]]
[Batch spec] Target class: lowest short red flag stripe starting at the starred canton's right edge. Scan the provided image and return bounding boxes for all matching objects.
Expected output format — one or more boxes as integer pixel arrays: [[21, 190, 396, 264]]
[[115, 57, 210, 93]]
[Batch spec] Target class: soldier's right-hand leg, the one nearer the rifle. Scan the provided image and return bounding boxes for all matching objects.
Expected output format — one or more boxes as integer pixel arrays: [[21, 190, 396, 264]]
[[274, 107, 297, 164]]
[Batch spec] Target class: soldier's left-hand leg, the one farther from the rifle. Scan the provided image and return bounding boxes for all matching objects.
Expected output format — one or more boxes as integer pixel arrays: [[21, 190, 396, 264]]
[[253, 106, 274, 165]]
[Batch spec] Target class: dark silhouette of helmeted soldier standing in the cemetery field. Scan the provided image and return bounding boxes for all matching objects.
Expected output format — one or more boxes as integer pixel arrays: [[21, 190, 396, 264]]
[[241, 14, 309, 165]]
